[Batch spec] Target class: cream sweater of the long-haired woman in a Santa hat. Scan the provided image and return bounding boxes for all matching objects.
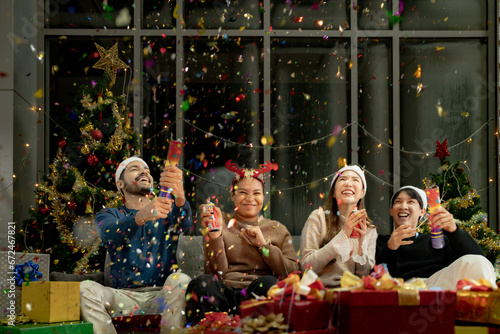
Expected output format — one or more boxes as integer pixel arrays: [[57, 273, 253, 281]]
[[300, 209, 377, 288]]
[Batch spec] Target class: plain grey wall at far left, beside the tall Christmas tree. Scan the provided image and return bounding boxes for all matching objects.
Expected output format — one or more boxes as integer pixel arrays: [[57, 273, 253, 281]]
[[0, 0, 39, 249]]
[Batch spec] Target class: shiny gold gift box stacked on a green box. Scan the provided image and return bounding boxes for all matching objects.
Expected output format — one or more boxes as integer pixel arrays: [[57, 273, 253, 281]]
[[22, 282, 80, 323]]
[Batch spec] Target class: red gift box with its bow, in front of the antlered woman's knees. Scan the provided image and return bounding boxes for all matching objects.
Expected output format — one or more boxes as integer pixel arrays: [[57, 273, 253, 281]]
[[240, 270, 334, 333]]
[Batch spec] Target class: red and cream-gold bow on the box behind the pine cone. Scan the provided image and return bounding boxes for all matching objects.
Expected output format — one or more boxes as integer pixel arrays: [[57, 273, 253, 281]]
[[267, 270, 325, 300]]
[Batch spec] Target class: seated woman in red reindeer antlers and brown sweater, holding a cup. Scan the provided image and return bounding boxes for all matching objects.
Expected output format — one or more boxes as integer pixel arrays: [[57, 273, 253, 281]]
[[186, 161, 299, 324]]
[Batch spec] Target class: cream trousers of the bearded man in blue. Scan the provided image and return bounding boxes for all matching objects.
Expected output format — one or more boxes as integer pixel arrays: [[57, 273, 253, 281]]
[[80, 273, 191, 334]]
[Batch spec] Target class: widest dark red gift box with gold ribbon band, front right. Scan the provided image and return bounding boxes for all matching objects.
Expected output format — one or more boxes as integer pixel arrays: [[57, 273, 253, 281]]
[[327, 289, 456, 334]]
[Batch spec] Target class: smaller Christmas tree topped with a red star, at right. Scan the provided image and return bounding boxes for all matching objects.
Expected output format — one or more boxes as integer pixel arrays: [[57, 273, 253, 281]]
[[419, 140, 500, 277]]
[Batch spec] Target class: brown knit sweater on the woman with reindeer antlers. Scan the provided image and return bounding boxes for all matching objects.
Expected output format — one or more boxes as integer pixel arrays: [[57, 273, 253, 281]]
[[204, 213, 299, 289]]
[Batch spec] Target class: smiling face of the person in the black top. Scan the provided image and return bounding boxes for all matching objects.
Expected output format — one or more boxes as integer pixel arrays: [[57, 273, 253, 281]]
[[390, 190, 425, 228]]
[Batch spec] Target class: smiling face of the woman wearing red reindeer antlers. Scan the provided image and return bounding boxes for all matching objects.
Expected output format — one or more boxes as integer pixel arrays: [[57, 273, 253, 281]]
[[231, 177, 264, 221]]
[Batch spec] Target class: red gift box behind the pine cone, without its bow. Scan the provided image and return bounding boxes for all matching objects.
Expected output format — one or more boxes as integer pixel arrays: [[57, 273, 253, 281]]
[[240, 299, 333, 332]]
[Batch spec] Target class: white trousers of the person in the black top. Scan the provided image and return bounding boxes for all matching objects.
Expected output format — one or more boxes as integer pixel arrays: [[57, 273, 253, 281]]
[[426, 255, 496, 290]]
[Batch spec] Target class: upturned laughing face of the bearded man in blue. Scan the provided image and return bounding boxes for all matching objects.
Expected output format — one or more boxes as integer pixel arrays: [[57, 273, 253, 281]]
[[116, 161, 153, 196]]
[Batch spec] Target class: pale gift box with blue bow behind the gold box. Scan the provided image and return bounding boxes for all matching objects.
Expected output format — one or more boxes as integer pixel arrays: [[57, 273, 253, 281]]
[[0, 251, 50, 320]]
